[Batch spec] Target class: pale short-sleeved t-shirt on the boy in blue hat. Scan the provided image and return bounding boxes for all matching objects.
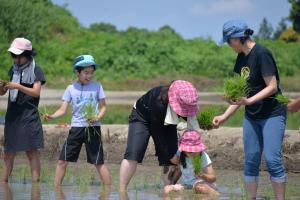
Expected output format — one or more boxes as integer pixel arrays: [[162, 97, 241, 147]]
[[62, 81, 105, 127]]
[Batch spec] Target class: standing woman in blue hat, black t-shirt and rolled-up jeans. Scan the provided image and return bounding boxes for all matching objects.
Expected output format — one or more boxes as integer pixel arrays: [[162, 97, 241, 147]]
[[213, 20, 287, 199]]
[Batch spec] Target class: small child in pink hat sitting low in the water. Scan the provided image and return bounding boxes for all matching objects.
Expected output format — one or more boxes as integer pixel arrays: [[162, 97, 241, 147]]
[[164, 130, 219, 196]]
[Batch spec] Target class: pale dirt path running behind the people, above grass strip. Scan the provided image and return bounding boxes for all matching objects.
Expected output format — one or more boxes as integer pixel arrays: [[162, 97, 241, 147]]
[[0, 89, 300, 109]]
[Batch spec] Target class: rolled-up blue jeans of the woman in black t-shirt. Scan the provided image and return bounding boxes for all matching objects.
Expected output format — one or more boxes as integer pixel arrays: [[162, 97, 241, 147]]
[[243, 115, 286, 183]]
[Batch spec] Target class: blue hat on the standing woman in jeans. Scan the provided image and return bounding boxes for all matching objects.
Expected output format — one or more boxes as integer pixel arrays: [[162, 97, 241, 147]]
[[220, 20, 248, 44]]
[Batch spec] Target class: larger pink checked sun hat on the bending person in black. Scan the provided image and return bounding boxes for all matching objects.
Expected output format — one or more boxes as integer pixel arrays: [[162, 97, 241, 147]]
[[168, 80, 199, 117]]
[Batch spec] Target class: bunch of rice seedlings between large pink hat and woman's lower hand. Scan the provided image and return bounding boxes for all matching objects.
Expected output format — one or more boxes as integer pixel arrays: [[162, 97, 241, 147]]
[[197, 107, 217, 130]]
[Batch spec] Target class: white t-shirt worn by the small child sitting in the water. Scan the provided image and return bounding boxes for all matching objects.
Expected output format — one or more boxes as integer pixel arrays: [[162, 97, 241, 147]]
[[180, 151, 212, 186]]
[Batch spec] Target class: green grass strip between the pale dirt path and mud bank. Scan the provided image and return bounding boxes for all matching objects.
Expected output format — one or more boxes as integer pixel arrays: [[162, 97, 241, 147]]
[[0, 105, 300, 130]]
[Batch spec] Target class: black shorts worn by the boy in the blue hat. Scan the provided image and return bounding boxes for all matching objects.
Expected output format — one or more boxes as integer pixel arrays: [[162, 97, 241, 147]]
[[59, 126, 104, 165]]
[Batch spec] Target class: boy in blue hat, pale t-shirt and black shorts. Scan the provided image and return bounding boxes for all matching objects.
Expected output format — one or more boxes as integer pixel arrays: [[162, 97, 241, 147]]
[[44, 55, 111, 187]]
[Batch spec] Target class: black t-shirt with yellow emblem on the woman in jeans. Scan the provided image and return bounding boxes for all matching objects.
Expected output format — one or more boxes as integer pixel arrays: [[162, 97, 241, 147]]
[[234, 44, 286, 119]]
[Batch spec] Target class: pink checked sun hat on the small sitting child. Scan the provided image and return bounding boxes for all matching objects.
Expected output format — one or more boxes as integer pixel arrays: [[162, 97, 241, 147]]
[[179, 130, 206, 153]]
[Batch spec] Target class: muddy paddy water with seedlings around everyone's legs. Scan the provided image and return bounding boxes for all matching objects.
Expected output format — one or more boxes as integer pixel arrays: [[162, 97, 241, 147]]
[[0, 161, 300, 200]]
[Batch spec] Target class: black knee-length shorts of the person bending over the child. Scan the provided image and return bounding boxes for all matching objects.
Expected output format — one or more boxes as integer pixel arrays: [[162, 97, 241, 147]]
[[124, 109, 178, 166]]
